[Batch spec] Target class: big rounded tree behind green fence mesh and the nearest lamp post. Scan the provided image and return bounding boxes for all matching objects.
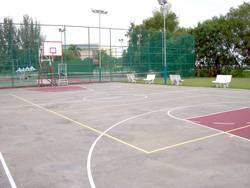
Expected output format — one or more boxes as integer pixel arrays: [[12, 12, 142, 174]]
[[123, 10, 193, 73]]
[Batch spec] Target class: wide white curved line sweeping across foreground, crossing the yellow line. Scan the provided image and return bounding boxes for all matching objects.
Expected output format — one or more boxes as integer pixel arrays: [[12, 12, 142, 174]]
[[87, 109, 164, 188]]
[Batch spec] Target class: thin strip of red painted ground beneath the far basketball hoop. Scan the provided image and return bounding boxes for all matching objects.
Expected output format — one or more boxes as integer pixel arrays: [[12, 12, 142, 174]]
[[28, 86, 86, 92]]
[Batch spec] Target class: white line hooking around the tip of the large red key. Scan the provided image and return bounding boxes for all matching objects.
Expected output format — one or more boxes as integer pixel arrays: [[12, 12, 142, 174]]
[[167, 102, 250, 141]]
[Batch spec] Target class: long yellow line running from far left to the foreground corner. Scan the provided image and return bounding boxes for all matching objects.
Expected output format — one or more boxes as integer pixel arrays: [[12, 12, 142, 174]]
[[10, 94, 149, 154]]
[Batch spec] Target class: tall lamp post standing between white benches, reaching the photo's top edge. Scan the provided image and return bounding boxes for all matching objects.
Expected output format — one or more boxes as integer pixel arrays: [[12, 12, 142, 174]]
[[158, 0, 168, 85]]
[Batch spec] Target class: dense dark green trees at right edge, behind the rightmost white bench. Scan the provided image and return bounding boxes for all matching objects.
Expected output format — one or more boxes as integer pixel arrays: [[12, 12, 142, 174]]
[[191, 3, 250, 76]]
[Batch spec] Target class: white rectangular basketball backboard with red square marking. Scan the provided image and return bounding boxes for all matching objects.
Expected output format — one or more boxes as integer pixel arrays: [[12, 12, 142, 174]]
[[43, 41, 62, 56]]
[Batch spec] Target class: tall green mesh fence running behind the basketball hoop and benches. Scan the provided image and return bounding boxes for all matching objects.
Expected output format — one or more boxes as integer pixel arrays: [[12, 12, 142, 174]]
[[0, 24, 195, 87]]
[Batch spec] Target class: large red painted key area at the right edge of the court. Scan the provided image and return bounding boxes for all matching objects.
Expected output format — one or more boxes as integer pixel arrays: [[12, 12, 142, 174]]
[[188, 108, 250, 139]]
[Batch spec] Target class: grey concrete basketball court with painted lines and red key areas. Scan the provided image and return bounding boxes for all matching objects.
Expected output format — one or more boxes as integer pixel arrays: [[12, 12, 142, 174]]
[[0, 83, 250, 188]]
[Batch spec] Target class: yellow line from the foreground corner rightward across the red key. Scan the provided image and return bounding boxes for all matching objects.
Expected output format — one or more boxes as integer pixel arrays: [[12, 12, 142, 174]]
[[149, 125, 250, 154]]
